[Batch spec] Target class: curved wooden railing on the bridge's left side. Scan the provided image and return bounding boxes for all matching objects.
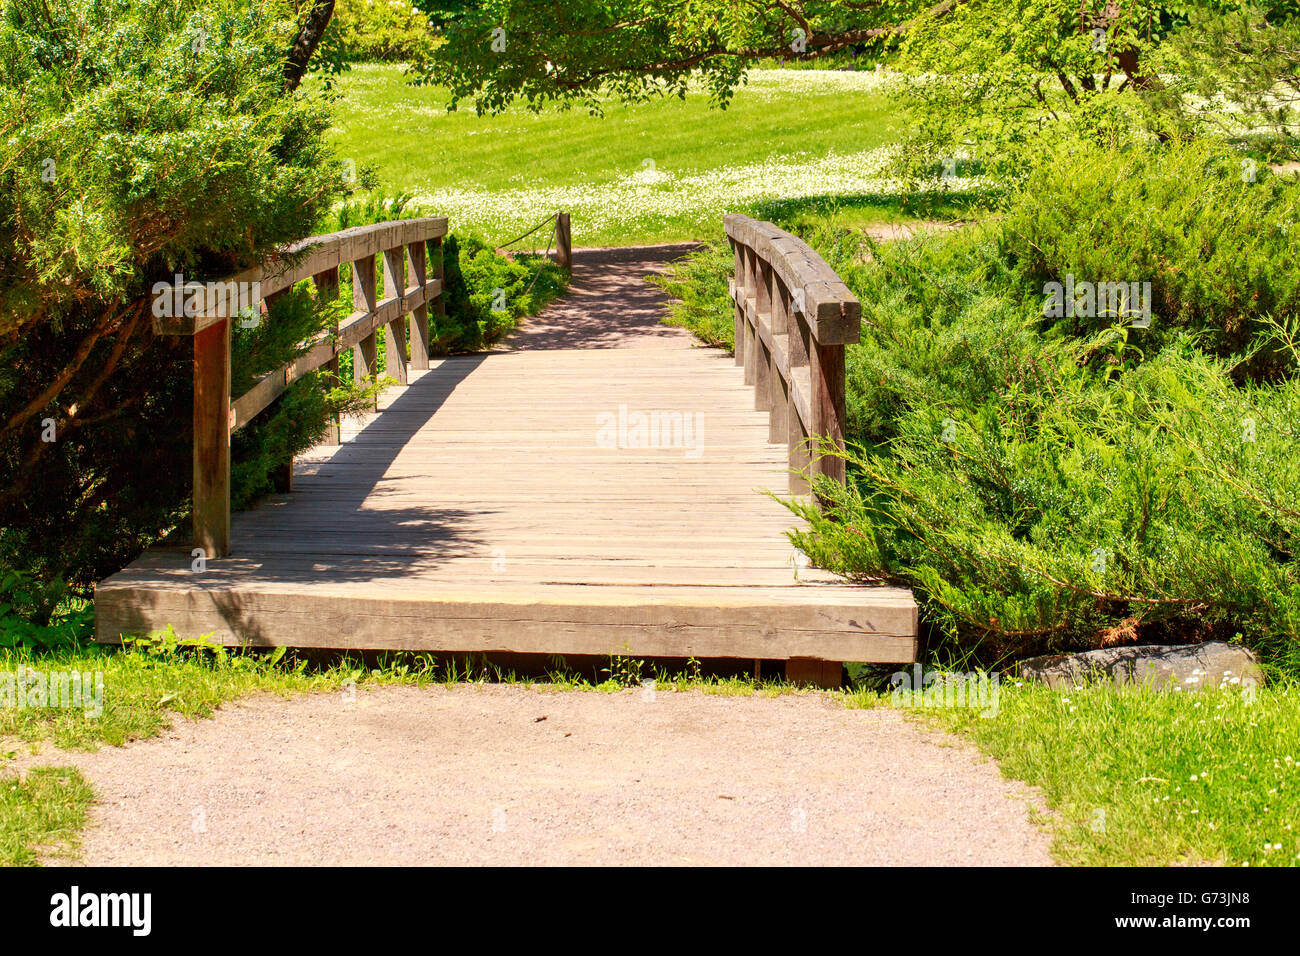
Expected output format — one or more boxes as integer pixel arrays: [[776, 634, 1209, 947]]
[[153, 216, 447, 558]]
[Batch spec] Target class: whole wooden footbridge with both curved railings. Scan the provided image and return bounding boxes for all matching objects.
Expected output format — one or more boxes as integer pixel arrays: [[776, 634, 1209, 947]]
[[95, 216, 917, 685]]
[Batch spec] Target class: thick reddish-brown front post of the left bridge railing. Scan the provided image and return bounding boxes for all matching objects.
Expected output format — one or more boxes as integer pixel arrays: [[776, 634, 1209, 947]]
[[194, 319, 231, 558]]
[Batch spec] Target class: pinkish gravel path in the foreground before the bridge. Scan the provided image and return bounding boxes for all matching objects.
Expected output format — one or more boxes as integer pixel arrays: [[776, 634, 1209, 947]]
[[20, 685, 1049, 865]]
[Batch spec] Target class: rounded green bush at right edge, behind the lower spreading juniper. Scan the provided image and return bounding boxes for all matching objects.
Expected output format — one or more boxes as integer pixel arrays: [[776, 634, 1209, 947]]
[[1001, 140, 1300, 376]]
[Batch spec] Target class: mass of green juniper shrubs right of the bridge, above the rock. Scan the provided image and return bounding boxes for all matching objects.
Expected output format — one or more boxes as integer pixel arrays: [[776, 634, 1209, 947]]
[[667, 147, 1300, 672]]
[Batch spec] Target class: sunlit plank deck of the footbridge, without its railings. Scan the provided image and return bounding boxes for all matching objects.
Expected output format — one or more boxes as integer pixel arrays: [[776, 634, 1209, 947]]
[[96, 244, 917, 662]]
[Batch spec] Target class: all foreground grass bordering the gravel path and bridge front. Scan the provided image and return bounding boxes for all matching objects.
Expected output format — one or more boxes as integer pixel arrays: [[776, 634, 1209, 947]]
[[15, 645, 1300, 865]]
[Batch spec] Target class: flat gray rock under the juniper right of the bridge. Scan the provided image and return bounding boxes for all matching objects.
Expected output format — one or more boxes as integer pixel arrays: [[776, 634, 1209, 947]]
[[1021, 641, 1264, 691]]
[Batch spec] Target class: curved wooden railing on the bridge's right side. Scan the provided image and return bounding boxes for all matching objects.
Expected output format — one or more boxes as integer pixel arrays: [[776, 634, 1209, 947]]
[[723, 215, 862, 494]]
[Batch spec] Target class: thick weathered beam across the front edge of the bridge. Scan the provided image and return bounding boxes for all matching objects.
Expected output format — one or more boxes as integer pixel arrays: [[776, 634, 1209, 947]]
[[95, 588, 917, 663]]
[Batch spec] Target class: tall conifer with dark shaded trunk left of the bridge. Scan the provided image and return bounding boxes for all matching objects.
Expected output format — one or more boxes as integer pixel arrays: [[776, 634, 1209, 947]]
[[0, 0, 343, 591]]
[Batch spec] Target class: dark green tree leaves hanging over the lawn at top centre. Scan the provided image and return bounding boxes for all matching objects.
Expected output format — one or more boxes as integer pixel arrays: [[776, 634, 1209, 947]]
[[421, 0, 931, 113]]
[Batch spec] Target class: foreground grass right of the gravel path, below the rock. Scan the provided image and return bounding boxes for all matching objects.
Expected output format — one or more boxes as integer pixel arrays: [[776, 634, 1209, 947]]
[[907, 684, 1300, 866]]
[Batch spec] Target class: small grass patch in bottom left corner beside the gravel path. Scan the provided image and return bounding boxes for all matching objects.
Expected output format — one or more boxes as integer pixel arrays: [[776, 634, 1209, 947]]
[[0, 767, 91, 866]]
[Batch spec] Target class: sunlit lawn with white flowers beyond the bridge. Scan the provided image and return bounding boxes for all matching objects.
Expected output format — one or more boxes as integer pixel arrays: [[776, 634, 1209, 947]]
[[322, 65, 969, 246]]
